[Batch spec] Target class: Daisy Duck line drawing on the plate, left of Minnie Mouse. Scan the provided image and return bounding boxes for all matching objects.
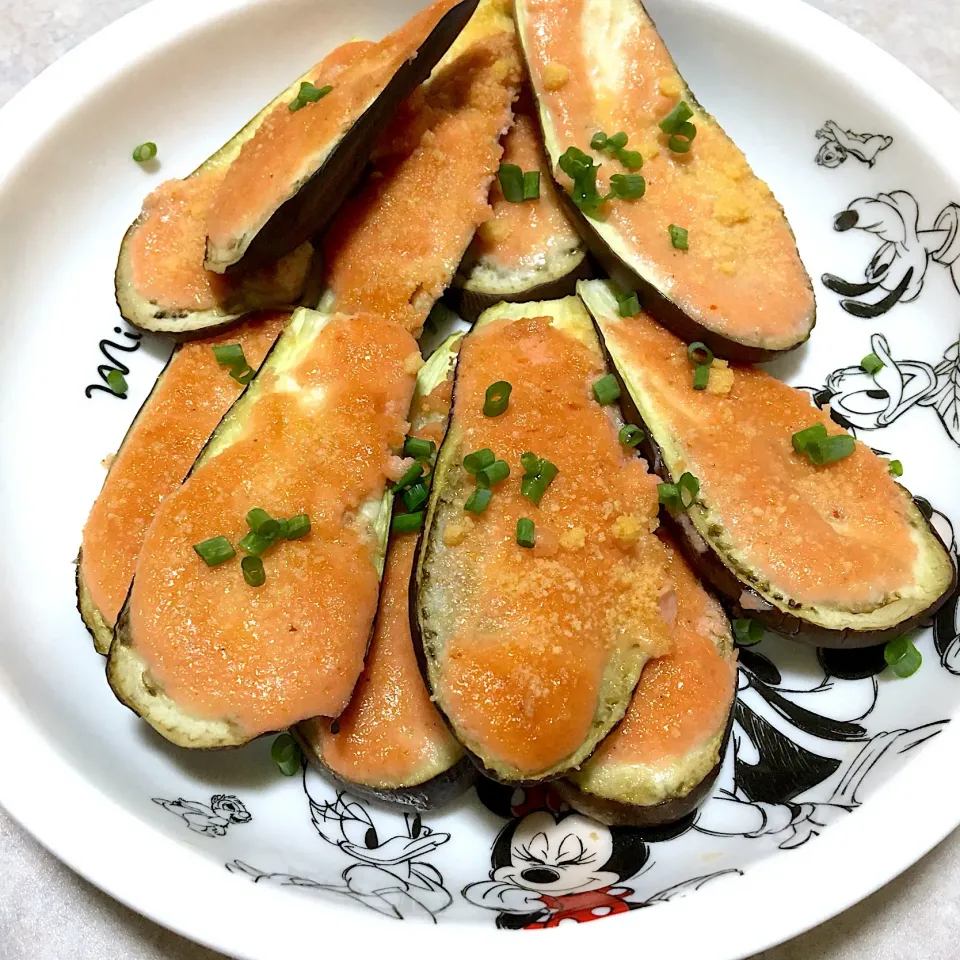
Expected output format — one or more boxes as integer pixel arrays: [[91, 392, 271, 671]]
[[226, 767, 453, 922]]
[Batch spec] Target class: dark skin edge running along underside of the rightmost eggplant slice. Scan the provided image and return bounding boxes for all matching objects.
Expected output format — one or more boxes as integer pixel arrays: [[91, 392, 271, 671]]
[[579, 284, 957, 650]]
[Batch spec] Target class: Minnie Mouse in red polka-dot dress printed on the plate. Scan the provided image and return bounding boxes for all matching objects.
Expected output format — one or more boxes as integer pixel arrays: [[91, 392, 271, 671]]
[[463, 784, 740, 930]]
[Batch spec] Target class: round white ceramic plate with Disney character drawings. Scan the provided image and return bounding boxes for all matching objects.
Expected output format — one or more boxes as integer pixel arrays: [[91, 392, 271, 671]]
[[0, 0, 960, 960]]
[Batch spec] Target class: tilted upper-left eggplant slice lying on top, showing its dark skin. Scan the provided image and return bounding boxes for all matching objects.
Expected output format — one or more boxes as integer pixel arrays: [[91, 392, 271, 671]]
[[204, 0, 477, 273]]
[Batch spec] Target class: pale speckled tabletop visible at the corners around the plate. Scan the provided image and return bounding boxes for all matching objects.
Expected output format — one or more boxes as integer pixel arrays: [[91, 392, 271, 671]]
[[0, 0, 960, 960]]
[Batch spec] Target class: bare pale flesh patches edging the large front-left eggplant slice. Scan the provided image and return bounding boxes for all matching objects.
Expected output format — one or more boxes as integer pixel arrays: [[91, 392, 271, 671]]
[[107, 307, 408, 749]]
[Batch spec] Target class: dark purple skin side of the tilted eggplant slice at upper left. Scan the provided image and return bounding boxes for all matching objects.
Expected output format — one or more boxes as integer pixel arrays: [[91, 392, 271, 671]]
[[227, 0, 479, 274]]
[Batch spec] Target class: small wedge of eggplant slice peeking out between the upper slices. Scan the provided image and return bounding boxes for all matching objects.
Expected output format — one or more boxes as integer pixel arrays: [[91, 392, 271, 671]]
[[453, 90, 590, 322]]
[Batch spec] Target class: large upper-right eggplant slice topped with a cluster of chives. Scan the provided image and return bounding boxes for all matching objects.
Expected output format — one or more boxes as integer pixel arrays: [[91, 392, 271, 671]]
[[516, 0, 816, 362]]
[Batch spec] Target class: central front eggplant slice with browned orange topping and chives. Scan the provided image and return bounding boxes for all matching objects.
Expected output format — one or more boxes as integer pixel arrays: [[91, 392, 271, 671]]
[[413, 297, 670, 783]]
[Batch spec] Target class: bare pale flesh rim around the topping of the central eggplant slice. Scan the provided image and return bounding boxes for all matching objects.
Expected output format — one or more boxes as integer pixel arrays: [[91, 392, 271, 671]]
[[410, 297, 676, 784]]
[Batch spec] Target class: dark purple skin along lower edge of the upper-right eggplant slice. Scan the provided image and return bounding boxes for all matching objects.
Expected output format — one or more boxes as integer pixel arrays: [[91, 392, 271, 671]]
[[557, 191, 816, 363]]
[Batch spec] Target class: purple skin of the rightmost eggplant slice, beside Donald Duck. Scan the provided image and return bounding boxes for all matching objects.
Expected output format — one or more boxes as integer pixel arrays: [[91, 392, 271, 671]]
[[596, 334, 957, 650]]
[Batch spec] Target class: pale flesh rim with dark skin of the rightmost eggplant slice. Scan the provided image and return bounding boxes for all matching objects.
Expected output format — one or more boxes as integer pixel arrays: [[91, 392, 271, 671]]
[[578, 281, 956, 648]]
